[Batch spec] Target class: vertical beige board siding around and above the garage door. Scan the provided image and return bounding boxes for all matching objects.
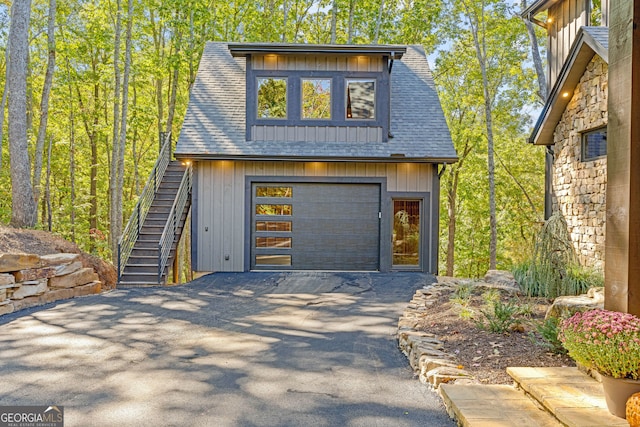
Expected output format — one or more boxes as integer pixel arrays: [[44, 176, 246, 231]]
[[192, 160, 436, 271]]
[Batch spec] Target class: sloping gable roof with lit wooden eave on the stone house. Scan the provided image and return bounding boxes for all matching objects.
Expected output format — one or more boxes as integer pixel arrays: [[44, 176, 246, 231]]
[[529, 27, 609, 145]]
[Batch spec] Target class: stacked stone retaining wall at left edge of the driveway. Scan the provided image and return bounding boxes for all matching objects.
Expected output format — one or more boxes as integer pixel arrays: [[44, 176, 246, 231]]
[[0, 253, 102, 315]]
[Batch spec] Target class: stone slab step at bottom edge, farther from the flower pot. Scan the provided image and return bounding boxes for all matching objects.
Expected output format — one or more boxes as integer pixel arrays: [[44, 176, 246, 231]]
[[439, 384, 562, 427]]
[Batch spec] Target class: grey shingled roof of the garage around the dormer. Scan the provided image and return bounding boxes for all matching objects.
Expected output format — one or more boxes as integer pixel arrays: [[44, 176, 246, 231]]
[[175, 42, 457, 163]]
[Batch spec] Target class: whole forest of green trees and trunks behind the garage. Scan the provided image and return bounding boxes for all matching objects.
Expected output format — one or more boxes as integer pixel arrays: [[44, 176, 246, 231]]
[[0, 0, 546, 277]]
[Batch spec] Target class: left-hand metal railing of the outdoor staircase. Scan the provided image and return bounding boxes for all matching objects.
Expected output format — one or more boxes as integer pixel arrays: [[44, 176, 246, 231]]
[[118, 132, 171, 283]]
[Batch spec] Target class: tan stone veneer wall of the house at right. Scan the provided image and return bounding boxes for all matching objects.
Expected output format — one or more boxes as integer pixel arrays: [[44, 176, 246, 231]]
[[552, 55, 608, 271]]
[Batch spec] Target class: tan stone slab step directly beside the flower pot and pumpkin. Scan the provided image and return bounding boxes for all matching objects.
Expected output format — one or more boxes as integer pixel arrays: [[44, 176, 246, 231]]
[[507, 367, 629, 427]]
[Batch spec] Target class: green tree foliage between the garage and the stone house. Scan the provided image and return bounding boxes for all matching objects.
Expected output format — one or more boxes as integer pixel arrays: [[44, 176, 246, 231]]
[[434, 0, 544, 277]]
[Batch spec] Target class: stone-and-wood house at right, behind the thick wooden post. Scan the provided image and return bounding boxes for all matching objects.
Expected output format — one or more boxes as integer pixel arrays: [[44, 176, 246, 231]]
[[522, 0, 609, 271]]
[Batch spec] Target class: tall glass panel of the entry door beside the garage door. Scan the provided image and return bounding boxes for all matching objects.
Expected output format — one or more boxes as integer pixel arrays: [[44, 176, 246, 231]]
[[392, 200, 420, 266]]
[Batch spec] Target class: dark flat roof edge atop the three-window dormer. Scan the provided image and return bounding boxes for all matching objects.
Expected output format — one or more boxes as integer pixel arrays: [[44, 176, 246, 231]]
[[229, 43, 407, 59]]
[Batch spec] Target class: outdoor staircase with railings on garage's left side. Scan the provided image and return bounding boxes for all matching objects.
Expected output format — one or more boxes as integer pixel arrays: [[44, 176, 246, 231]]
[[118, 138, 191, 286]]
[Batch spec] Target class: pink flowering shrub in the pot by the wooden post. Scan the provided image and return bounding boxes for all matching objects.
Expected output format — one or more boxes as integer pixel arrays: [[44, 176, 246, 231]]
[[559, 309, 640, 380]]
